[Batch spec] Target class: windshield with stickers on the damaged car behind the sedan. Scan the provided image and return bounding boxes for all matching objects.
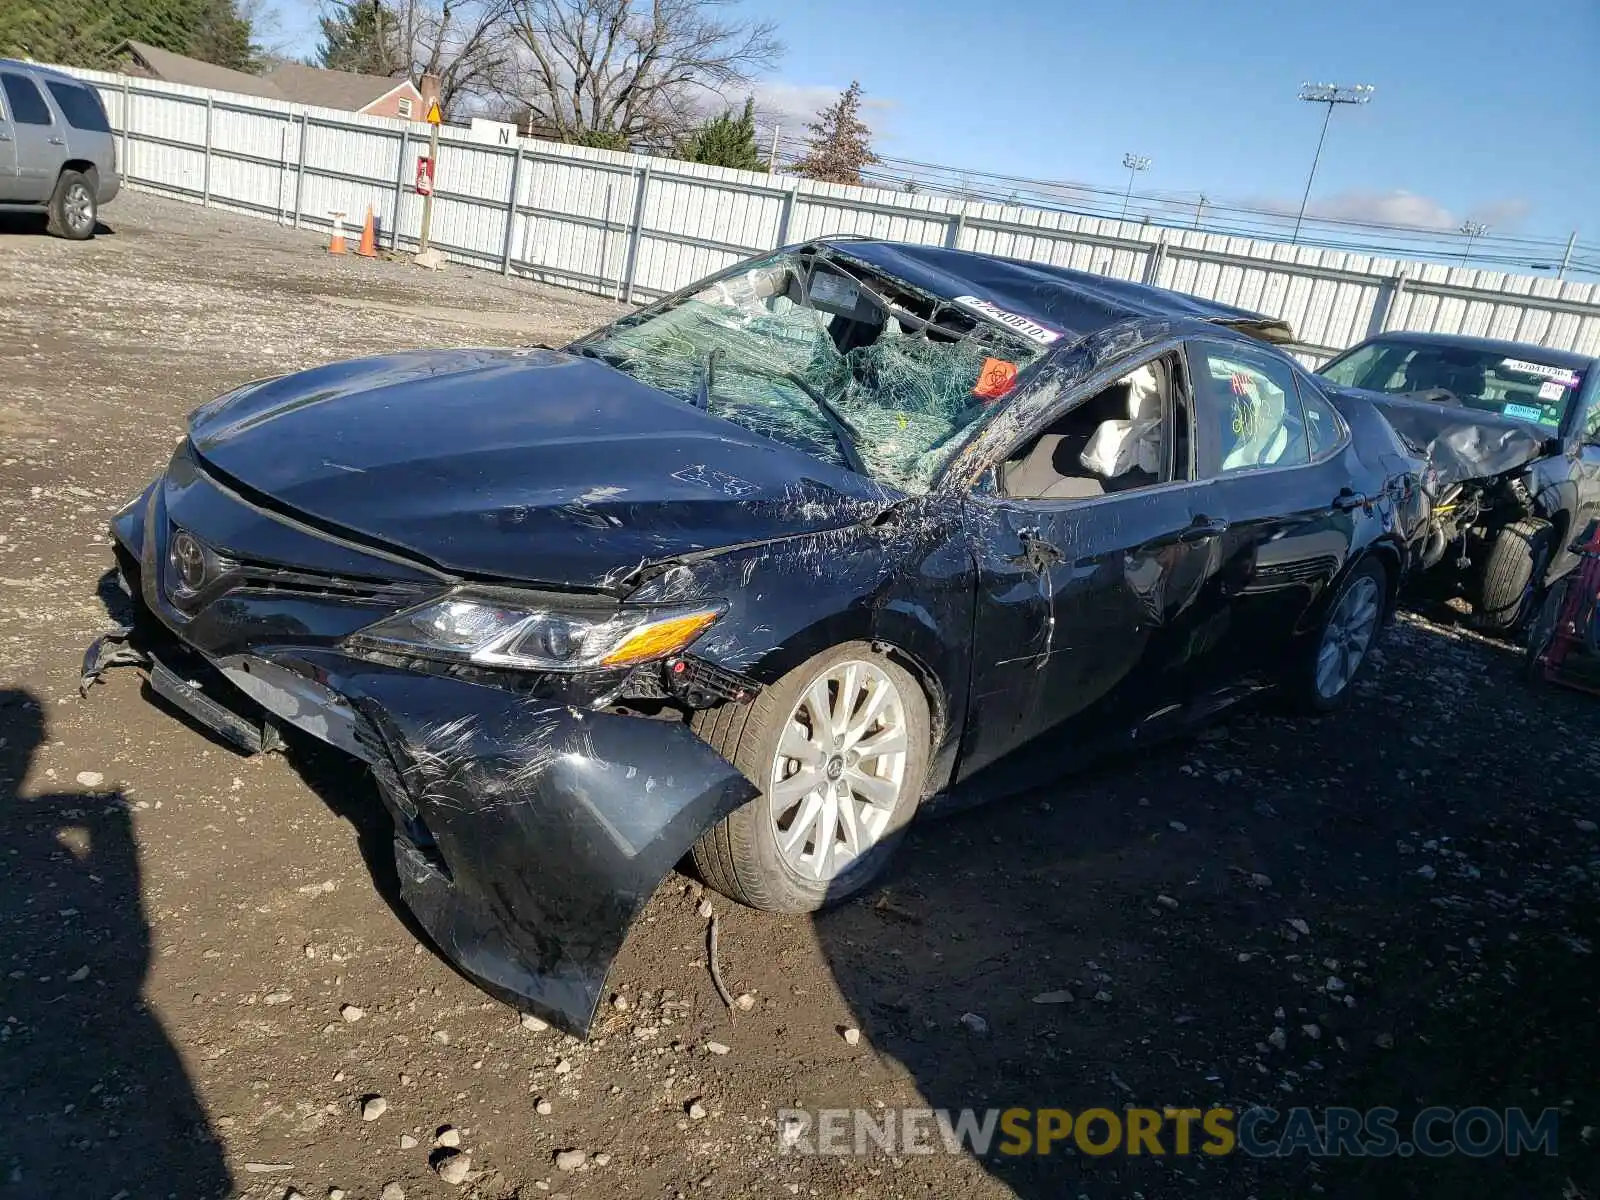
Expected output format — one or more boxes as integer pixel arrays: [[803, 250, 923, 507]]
[[1322, 339, 1582, 429]]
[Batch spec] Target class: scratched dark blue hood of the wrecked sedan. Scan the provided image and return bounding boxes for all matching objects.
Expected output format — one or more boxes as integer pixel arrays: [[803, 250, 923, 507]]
[[190, 350, 885, 587]]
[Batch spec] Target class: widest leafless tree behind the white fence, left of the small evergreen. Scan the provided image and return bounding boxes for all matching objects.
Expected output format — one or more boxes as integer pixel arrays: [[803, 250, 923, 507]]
[[510, 0, 782, 149]]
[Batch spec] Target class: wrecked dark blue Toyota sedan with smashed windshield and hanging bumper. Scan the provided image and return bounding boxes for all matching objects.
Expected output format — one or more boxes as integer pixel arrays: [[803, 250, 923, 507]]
[[85, 238, 1422, 1032]]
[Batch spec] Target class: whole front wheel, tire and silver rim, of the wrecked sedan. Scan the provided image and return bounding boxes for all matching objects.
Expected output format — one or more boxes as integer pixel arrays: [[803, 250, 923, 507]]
[[693, 643, 930, 912]]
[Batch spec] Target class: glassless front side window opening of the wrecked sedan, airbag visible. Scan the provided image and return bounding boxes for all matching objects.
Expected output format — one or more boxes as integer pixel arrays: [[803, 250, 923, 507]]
[[998, 355, 1190, 499]]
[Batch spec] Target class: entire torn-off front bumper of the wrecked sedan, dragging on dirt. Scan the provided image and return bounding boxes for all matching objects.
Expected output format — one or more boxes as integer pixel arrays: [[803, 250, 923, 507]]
[[103, 454, 755, 1037]]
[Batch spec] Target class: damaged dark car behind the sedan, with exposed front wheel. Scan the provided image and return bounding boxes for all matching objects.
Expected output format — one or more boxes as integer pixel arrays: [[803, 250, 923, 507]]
[[1318, 331, 1600, 634]]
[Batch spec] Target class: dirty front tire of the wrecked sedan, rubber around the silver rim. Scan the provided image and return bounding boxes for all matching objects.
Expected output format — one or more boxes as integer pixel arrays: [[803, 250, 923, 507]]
[[693, 642, 931, 914]]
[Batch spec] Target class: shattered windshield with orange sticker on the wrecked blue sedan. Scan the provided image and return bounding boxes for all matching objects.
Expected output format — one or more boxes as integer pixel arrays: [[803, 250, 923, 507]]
[[573, 251, 1043, 491]]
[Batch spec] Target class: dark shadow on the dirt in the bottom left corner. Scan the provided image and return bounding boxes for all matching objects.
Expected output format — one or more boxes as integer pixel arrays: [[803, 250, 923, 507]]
[[0, 688, 232, 1200]]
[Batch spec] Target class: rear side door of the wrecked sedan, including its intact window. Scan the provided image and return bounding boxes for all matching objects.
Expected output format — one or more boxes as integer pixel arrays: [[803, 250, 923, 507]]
[[1189, 339, 1381, 688]]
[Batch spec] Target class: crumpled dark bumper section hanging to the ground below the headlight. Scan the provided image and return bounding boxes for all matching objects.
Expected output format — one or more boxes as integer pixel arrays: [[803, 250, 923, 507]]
[[300, 656, 757, 1037]]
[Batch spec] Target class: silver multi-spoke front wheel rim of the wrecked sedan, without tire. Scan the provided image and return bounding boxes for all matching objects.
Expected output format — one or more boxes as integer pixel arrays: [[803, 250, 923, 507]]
[[766, 659, 910, 882]]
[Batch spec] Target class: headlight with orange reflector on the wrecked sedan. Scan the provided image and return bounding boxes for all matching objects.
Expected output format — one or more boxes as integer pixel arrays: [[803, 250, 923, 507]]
[[349, 589, 725, 670]]
